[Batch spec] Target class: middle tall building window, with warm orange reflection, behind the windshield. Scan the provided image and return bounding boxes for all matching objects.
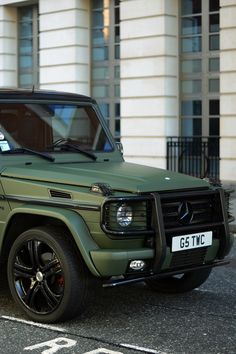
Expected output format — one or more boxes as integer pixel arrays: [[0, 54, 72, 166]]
[[91, 0, 120, 141]]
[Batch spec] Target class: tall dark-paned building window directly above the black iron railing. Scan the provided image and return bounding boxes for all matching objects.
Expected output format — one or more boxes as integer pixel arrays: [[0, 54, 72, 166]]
[[180, 0, 220, 136]]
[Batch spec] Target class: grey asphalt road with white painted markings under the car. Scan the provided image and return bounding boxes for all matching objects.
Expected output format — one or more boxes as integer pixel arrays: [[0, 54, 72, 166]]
[[0, 240, 236, 354]]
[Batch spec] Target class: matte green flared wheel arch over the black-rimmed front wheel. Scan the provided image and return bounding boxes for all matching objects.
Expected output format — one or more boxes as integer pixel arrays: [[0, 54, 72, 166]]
[[2, 205, 100, 276]]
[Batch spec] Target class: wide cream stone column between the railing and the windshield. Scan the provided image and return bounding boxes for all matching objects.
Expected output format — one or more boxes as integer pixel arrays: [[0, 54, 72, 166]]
[[120, 0, 179, 168]]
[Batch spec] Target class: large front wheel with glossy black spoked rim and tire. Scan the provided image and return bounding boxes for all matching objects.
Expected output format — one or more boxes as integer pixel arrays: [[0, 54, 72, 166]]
[[7, 227, 89, 323]]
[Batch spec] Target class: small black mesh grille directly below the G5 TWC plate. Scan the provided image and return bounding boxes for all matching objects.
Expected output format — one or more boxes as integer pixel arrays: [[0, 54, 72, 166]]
[[170, 247, 207, 268]]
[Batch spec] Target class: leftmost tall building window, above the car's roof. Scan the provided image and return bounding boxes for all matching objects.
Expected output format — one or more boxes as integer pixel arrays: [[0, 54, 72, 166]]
[[18, 5, 39, 88]]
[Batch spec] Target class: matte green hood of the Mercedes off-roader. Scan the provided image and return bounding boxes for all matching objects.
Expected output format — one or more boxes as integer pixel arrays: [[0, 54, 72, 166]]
[[1, 162, 209, 193]]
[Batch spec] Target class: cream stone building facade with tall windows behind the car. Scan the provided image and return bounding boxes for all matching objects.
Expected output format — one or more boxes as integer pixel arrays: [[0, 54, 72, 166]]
[[0, 0, 236, 187]]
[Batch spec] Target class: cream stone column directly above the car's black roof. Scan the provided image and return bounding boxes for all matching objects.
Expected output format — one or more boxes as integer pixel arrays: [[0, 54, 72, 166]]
[[39, 0, 90, 95]]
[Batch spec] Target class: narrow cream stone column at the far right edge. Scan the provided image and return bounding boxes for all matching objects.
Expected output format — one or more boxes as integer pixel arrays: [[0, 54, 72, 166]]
[[220, 0, 236, 184]]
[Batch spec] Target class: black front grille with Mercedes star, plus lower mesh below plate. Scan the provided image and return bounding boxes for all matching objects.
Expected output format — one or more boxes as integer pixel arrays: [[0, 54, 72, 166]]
[[157, 190, 224, 268]]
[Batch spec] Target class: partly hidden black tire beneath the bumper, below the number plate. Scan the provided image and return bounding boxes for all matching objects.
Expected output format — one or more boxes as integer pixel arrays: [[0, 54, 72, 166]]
[[146, 268, 211, 294]]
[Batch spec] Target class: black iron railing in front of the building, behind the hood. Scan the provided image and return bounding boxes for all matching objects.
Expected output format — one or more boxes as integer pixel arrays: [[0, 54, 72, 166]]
[[167, 137, 220, 182]]
